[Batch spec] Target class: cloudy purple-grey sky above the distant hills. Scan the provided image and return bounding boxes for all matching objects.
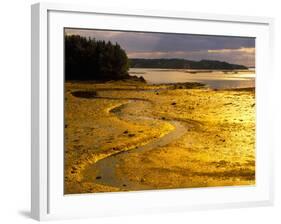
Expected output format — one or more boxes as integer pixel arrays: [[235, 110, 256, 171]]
[[65, 28, 255, 67]]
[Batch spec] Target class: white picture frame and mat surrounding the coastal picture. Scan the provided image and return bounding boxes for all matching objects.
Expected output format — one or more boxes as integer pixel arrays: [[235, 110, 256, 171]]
[[31, 3, 274, 220]]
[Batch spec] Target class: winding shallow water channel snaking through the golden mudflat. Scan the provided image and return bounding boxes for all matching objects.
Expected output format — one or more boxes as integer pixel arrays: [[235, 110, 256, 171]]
[[80, 90, 198, 191]]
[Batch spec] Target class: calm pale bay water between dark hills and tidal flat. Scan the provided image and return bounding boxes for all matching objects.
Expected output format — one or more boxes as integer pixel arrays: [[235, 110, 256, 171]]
[[129, 68, 255, 89]]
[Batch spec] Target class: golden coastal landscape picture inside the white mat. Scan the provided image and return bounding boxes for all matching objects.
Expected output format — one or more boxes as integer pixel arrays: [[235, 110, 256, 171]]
[[63, 27, 256, 194]]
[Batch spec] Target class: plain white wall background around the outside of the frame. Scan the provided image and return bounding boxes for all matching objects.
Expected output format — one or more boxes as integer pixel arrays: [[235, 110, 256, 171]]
[[0, 0, 281, 224]]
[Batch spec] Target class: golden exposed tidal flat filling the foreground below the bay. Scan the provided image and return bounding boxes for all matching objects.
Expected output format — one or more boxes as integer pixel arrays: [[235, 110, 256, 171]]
[[65, 76, 255, 194]]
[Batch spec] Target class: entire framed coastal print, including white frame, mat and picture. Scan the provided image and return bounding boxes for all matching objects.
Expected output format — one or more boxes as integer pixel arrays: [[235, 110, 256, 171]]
[[31, 3, 273, 220]]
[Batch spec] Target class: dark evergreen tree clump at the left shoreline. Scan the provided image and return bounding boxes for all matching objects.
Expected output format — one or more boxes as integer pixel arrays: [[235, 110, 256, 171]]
[[64, 35, 130, 80]]
